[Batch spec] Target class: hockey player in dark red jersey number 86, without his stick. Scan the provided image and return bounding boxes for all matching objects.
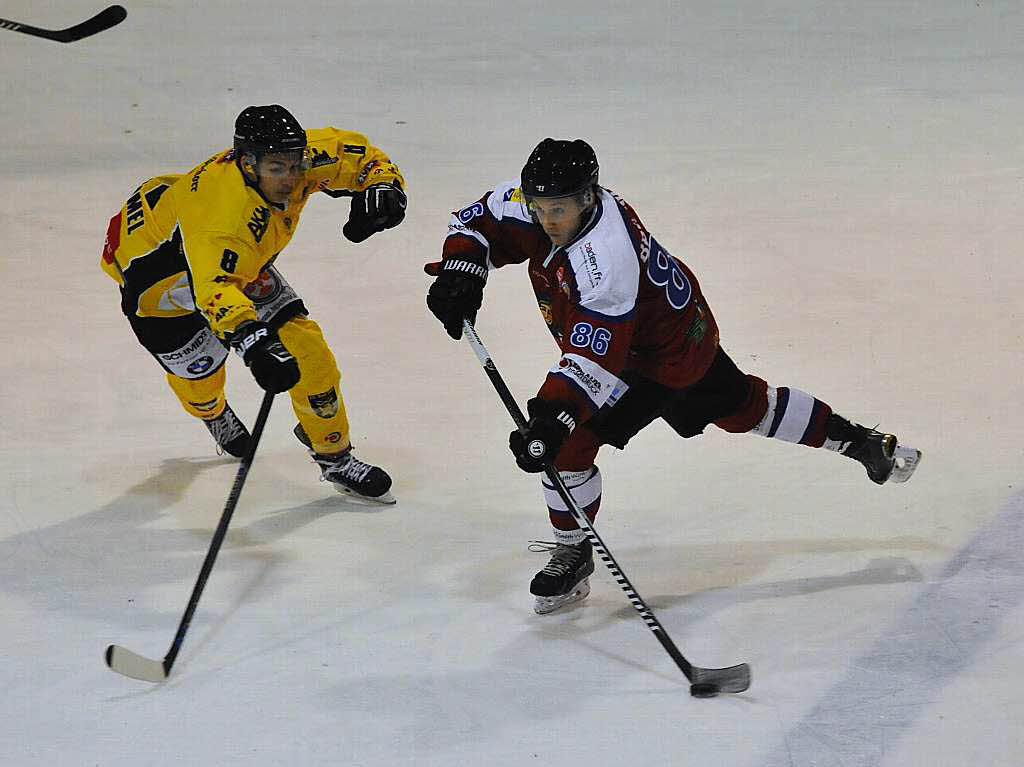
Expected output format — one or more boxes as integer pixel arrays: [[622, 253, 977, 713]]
[[426, 138, 921, 613]]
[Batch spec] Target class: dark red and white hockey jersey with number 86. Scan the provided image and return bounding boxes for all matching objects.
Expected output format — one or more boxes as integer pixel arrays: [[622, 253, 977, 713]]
[[443, 182, 718, 423]]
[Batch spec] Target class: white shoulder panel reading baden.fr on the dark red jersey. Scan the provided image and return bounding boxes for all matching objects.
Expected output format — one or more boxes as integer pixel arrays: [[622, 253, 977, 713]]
[[567, 189, 640, 317]]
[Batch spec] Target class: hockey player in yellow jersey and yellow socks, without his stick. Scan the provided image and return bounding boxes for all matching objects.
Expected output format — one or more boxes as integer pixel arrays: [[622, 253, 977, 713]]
[[101, 104, 406, 503]]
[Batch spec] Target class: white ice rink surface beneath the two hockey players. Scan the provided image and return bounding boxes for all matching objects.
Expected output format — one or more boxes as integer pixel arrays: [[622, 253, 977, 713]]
[[0, 0, 1024, 767]]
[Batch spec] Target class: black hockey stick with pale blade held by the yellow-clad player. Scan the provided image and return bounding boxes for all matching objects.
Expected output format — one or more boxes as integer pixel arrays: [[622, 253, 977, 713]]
[[105, 391, 273, 682]]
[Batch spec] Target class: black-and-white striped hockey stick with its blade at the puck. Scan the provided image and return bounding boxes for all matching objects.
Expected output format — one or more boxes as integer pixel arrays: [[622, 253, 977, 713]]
[[463, 319, 751, 697]]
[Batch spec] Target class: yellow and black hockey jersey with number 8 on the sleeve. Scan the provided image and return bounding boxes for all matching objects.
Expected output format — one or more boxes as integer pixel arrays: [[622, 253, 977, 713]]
[[100, 128, 406, 338]]
